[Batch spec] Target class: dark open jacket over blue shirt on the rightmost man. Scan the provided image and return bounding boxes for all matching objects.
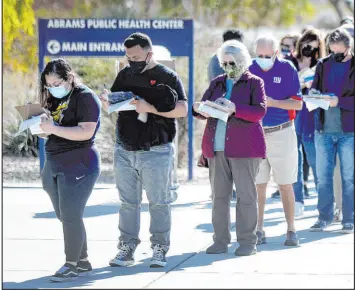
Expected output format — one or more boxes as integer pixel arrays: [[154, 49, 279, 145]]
[[312, 56, 355, 132]]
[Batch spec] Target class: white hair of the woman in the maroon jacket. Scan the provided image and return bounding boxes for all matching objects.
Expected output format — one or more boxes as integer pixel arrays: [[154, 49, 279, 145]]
[[217, 39, 252, 69]]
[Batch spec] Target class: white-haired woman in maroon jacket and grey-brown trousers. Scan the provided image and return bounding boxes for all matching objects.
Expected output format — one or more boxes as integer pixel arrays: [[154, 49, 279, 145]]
[[192, 40, 266, 256]]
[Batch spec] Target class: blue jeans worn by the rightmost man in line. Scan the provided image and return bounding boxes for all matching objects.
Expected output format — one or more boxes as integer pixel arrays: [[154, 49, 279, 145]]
[[315, 132, 354, 224]]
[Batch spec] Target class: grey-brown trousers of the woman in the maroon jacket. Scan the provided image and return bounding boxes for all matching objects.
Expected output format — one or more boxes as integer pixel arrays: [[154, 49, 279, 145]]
[[208, 152, 262, 246]]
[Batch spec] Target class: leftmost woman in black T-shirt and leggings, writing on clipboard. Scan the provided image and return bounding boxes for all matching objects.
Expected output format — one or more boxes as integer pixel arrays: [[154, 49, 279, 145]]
[[40, 59, 101, 282]]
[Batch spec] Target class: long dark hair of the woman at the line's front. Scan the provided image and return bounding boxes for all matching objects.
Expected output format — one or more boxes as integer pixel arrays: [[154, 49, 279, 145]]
[[39, 58, 81, 111]]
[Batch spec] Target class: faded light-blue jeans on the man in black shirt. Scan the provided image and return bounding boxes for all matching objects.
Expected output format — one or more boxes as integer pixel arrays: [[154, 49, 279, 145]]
[[114, 143, 174, 251]]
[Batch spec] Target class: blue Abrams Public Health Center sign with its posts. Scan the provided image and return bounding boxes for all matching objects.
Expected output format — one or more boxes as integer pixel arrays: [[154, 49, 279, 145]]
[[39, 19, 194, 180]]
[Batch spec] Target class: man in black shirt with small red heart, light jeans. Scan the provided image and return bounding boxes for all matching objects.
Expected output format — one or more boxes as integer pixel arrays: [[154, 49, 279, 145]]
[[100, 33, 188, 267]]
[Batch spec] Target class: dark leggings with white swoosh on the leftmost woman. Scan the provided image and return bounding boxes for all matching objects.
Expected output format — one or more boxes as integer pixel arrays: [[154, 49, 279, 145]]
[[41, 147, 100, 262]]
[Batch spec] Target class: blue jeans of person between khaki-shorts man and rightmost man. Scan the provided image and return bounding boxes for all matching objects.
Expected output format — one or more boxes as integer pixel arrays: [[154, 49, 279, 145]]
[[293, 134, 317, 203]]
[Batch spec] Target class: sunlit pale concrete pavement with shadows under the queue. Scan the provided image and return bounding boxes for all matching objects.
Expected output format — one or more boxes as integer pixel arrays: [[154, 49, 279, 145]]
[[3, 184, 354, 289]]
